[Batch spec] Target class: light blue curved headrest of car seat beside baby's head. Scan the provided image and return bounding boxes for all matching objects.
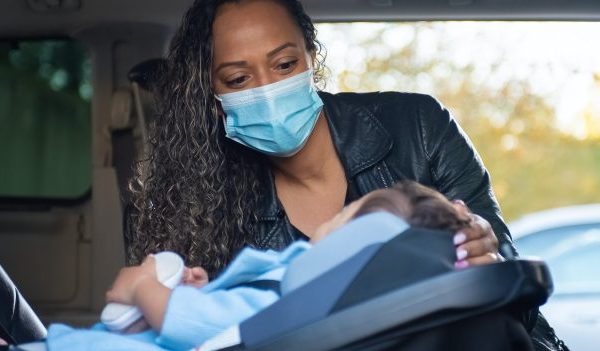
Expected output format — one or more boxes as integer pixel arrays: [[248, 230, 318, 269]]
[[281, 212, 409, 295]]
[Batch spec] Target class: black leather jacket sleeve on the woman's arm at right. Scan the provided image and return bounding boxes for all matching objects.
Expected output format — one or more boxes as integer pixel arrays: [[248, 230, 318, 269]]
[[419, 96, 516, 255]]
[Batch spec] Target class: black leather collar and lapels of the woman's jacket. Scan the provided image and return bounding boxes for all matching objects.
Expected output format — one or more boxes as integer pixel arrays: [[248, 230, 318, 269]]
[[258, 92, 393, 220]]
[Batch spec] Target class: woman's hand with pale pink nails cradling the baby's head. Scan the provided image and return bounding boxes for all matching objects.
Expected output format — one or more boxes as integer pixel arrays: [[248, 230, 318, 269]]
[[453, 200, 503, 268]]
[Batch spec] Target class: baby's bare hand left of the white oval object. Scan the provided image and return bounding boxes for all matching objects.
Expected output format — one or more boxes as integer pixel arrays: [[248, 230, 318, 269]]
[[106, 255, 157, 305]]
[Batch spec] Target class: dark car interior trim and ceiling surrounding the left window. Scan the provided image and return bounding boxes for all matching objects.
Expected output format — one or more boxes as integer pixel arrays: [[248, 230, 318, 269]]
[[0, 0, 600, 349]]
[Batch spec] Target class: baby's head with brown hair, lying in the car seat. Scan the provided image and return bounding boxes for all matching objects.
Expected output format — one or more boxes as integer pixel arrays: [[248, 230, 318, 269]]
[[311, 180, 471, 242]]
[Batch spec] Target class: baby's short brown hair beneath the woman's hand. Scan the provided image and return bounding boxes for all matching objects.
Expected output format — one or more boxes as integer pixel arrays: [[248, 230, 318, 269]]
[[354, 180, 471, 232]]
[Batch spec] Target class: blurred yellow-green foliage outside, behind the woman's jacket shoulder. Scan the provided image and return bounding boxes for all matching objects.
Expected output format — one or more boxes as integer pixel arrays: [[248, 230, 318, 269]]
[[330, 23, 600, 220]]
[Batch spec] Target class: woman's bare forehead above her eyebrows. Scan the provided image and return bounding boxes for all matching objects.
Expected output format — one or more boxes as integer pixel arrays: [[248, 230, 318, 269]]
[[213, 0, 305, 60]]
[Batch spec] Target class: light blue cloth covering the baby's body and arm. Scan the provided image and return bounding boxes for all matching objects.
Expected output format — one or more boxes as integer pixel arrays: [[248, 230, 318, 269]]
[[47, 242, 310, 351]]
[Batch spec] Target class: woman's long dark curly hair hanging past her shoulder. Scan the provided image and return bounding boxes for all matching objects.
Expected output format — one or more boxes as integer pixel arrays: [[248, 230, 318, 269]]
[[128, 0, 325, 276]]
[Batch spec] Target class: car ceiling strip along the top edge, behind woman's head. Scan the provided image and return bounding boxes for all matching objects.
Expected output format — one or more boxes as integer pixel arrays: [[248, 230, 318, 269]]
[[0, 0, 600, 37]]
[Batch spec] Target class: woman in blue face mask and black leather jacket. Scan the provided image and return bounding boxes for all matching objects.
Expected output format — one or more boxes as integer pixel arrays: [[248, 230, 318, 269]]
[[129, 0, 568, 350]]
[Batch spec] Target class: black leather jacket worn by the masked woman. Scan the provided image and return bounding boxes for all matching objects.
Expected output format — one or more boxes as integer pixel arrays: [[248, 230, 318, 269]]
[[256, 92, 514, 251]]
